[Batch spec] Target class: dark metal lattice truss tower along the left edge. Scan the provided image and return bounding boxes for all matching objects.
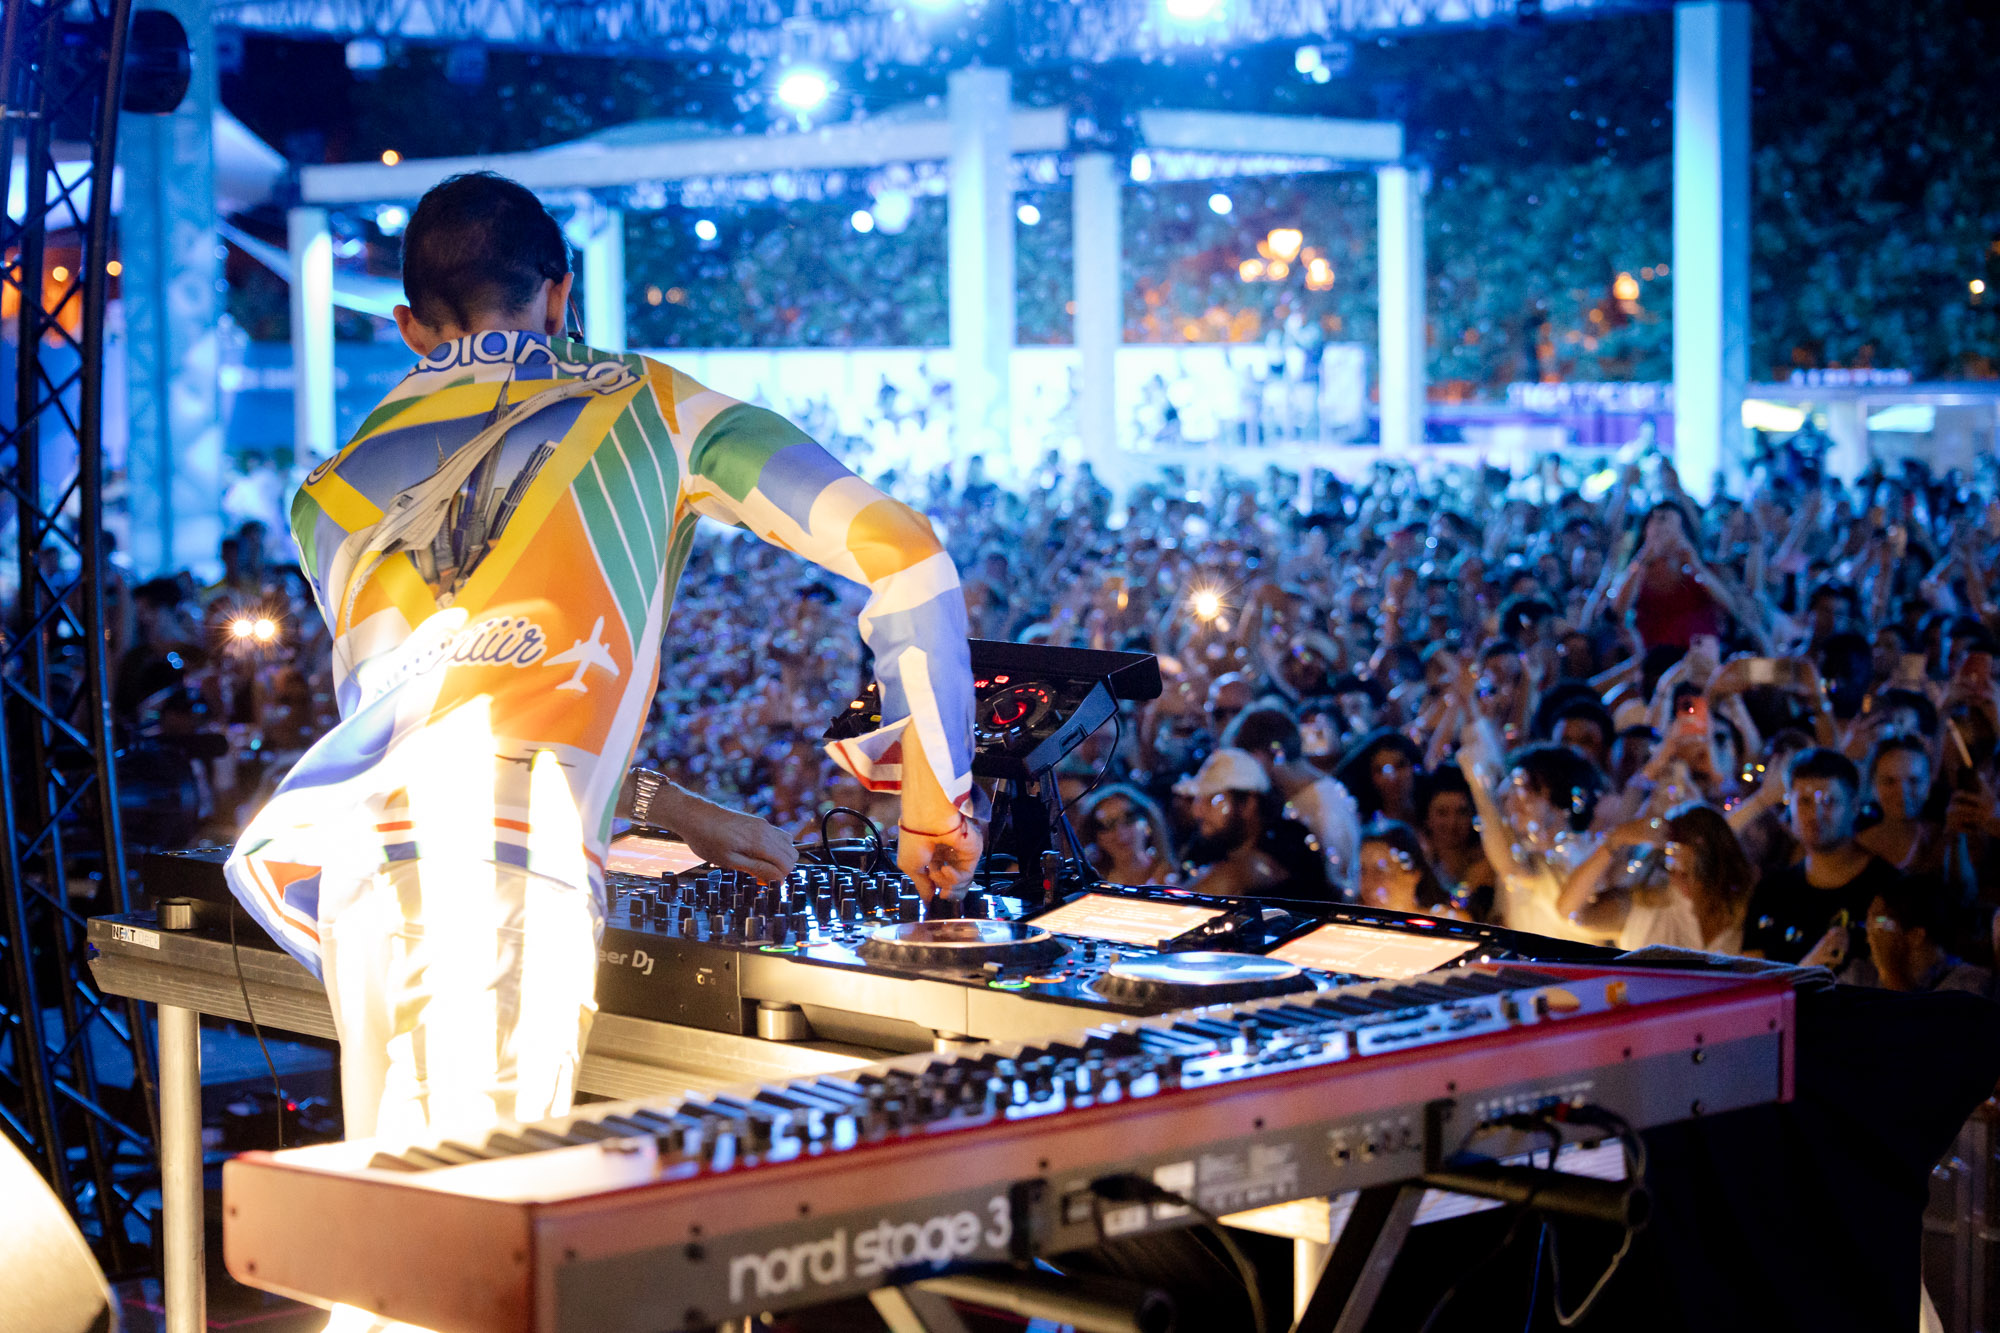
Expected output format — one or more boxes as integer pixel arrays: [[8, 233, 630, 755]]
[[0, 0, 158, 1275]]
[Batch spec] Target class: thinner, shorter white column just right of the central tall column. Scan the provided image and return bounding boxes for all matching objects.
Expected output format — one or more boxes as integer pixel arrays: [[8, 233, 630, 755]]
[[1070, 152, 1124, 460]]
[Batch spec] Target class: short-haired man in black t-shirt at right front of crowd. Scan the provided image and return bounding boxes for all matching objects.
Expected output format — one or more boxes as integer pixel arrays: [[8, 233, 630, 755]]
[[1744, 749, 1896, 967]]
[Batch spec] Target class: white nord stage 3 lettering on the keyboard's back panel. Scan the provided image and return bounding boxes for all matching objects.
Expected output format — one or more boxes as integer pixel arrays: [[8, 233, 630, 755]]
[[730, 1195, 1014, 1301]]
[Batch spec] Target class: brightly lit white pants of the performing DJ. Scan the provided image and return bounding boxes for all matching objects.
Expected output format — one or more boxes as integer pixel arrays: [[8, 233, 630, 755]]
[[320, 859, 602, 1333]]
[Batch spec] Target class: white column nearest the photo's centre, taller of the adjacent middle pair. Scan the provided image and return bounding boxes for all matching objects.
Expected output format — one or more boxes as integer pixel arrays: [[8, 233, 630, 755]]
[[946, 68, 1014, 472]]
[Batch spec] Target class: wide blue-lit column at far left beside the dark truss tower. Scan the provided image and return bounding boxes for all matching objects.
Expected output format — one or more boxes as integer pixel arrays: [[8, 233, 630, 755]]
[[118, 0, 222, 576]]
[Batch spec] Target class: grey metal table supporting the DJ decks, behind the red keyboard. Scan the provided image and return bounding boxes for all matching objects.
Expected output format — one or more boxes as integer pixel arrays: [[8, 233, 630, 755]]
[[90, 915, 882, 1333]]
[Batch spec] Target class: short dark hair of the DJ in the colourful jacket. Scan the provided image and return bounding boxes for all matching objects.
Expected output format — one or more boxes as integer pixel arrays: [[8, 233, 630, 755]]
[[402, 172, 570, 328]]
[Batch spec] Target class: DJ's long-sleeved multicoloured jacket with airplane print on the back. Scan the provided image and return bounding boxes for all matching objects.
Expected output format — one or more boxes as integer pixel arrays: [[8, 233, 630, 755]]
[[228, 332, 974, 971]]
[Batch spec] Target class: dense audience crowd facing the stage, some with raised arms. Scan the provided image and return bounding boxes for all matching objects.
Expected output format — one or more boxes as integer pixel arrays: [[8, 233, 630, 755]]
[[112, 426, 2000, 991]]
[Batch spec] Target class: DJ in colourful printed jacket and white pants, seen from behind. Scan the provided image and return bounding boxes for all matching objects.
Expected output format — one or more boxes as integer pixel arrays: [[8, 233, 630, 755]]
[[228, 174, 982, 1184]]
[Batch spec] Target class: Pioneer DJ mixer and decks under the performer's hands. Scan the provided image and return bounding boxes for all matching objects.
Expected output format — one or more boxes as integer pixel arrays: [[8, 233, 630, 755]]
[[598, 841, 1610, 1051]]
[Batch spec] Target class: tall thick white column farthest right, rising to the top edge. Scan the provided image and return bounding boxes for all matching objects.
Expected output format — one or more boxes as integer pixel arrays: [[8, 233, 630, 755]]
[[1672, 0, 1750, 500]]
